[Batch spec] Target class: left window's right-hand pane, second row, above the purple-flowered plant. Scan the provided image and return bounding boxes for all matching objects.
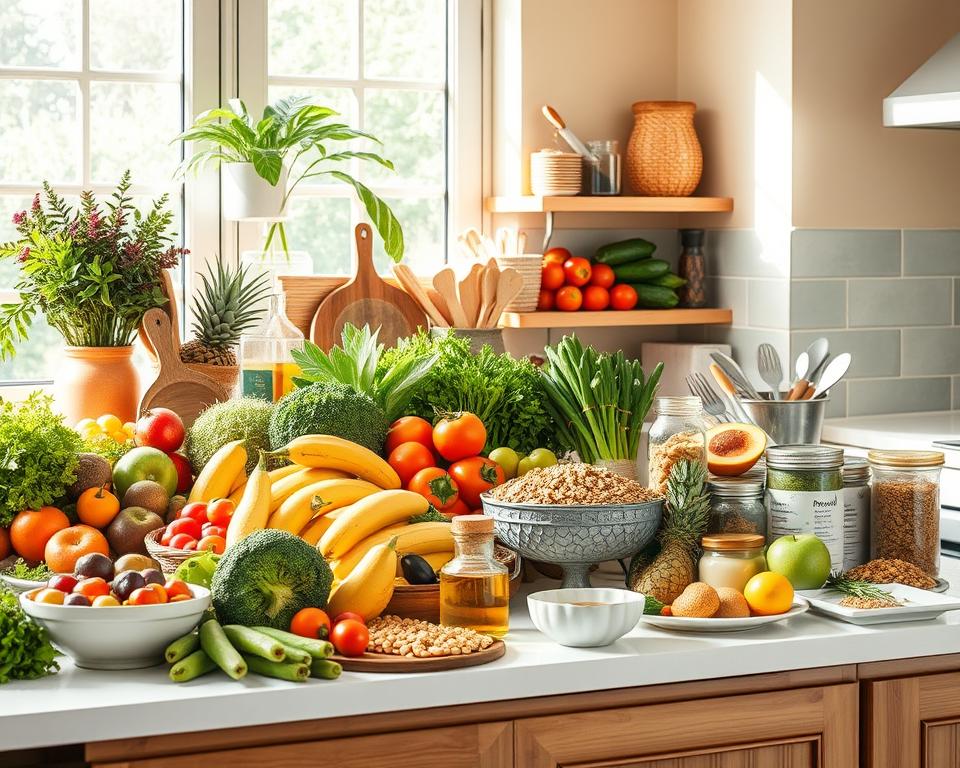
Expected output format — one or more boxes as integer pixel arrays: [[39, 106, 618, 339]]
[[90, 82, 182, 184]]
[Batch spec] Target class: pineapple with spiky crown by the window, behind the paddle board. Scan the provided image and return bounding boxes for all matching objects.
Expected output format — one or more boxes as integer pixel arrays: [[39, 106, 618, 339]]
[[180, 259, 270, 366]]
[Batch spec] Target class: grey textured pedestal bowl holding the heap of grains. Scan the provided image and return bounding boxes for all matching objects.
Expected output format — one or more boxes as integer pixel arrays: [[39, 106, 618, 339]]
[[480, 494, 663, 588]]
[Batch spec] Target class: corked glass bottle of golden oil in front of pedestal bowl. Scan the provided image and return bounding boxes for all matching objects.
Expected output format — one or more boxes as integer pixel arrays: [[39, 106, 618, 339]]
[[440, 515, 510, 638]]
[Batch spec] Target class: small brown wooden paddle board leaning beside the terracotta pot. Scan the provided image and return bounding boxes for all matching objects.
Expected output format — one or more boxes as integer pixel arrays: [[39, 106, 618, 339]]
[[140, 308, 229, 427]]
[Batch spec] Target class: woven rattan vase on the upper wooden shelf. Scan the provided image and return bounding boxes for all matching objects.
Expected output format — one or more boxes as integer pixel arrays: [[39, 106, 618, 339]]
[[625, 101, 703, 197]]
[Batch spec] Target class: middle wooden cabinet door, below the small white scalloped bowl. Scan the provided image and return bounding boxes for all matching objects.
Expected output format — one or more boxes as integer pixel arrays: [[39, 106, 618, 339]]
[[514, 683, 859, 768]]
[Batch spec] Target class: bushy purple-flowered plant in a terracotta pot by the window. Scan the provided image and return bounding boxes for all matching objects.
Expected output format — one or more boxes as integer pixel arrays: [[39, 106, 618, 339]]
[[0, 171, 187, 423]]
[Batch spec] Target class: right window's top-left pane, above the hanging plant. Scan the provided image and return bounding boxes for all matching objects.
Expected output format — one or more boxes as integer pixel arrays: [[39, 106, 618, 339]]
[[267, 0, 359, 78]]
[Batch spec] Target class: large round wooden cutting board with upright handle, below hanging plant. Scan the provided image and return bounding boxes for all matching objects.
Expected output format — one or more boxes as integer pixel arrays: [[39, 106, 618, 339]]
[[310, 224, 427, 350]]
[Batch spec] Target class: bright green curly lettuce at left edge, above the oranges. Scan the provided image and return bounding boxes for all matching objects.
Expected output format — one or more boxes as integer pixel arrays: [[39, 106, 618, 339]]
[[0, 392, 83, 527]]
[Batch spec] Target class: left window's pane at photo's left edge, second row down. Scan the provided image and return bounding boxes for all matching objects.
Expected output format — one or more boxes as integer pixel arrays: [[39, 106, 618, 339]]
[[0, 80, 81, 184]]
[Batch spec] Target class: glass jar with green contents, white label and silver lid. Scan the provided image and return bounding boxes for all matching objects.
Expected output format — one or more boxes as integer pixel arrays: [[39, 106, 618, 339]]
[[766, 445, 843, 570]]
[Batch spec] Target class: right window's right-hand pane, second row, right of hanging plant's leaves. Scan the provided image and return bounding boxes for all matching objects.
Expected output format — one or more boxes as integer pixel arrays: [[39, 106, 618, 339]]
[[361, 89, 446, 186]]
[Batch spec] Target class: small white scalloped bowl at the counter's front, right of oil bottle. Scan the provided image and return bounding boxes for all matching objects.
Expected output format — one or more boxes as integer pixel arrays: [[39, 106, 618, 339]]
[[527, 588, 643, 648]]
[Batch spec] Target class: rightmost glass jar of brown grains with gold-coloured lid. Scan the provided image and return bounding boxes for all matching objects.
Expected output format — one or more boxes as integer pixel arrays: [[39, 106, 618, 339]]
[[867, 451, 943, 578]]
